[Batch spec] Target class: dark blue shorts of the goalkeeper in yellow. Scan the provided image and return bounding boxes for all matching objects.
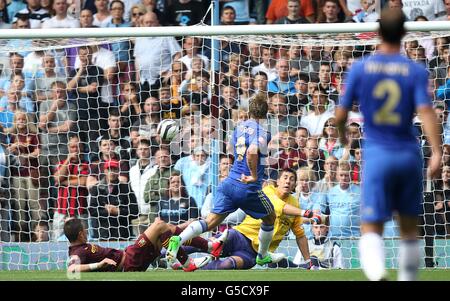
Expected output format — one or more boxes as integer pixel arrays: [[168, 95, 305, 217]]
[[216, 229, 258, 270]]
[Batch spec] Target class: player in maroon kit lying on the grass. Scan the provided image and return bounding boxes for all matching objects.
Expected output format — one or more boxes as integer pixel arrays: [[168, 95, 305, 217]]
[[64, 218, 223, 272]]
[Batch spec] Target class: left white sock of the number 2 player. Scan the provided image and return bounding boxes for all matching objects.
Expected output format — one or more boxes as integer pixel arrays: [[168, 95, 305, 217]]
[[359, 232, 386, 281]]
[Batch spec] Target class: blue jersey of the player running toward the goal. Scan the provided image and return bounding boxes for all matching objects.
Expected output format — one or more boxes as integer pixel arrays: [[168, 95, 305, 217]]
[[229, 119, 271, 186]]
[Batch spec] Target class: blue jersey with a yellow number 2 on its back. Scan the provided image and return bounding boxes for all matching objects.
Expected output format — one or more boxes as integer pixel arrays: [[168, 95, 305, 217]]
[[340, 54, 431, 147]]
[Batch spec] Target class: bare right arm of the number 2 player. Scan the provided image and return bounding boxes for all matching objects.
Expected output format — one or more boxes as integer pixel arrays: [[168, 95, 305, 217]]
[[417, 106, 442, 178]]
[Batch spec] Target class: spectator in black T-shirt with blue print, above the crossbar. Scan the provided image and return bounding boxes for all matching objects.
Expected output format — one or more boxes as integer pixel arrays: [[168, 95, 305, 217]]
[[164, 0, 205, 26]]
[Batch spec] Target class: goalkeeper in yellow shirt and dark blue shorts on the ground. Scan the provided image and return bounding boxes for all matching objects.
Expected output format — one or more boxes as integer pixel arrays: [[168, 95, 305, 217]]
[[196, 170, 324, 270]]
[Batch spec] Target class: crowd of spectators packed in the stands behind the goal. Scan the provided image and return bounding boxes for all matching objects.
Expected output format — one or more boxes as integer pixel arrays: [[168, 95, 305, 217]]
[[0, 0, 450, 241]]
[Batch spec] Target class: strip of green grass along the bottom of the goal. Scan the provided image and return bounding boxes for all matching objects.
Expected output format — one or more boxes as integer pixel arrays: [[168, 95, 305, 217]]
[[0, 269, 450, 281]]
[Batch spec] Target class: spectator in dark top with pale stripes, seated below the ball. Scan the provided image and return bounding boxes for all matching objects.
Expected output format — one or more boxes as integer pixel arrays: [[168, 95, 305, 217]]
[[158, 172, 200, 225]]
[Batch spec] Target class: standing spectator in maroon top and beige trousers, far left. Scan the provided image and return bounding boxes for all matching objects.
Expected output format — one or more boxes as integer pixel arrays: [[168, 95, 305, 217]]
[[7, 111, 41, 241]]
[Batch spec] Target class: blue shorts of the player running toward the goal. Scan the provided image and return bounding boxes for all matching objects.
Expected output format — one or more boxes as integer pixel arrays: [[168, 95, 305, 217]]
[[211, 178, 274, 219]]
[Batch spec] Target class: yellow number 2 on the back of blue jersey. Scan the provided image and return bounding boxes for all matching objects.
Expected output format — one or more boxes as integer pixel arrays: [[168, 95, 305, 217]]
[[373, 79, 401, 125]]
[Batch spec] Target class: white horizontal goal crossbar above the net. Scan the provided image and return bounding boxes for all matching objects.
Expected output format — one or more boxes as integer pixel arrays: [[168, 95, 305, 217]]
[[0, 21, 450, 39]]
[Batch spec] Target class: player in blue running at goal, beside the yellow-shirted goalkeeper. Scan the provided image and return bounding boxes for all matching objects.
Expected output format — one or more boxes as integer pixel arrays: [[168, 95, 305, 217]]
[[166, 94, 281, 265]]
